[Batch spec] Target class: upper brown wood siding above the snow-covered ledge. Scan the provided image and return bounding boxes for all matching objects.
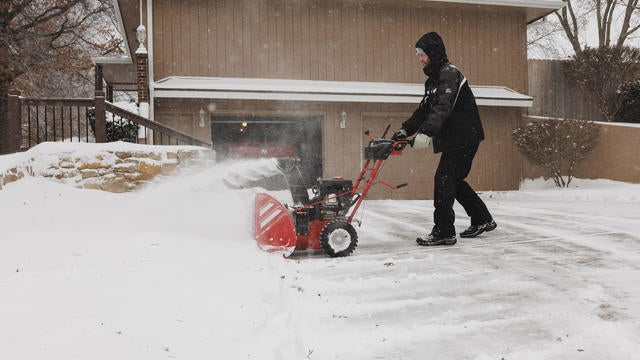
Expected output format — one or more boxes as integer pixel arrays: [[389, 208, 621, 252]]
[[153, 0, 527, 92]]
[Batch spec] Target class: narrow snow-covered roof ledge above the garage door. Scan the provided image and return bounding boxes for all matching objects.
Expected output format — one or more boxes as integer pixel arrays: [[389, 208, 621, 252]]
[[153, 76, 533, 107]]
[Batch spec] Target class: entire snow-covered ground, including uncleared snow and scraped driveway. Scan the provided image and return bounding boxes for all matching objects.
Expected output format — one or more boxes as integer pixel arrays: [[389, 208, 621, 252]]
[[0, 148, 640, 360]]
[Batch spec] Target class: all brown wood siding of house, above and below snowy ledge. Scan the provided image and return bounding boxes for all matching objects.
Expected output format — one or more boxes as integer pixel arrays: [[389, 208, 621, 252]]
[[153, 0, 527, 199]]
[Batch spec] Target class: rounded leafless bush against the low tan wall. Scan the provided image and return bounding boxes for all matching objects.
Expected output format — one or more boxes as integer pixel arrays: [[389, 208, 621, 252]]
[[512, 120, 600, 187]]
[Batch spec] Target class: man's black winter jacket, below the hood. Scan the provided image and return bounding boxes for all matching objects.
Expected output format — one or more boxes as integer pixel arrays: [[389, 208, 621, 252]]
[[402, 62, 484, 153]]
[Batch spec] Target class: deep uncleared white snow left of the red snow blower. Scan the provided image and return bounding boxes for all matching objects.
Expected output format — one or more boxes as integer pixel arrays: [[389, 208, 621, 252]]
[[0, 160, 306, 359]]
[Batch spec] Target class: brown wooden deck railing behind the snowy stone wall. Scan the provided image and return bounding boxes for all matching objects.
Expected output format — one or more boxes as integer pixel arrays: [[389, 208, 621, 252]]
[[0, 91, 211, 152]]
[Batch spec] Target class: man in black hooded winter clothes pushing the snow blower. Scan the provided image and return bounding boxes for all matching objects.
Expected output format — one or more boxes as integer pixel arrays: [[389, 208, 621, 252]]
[[392, 32, 497, 246]]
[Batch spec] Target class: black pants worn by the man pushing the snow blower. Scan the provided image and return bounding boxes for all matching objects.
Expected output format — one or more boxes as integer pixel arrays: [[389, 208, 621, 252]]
[[433, 144, 492, 237]]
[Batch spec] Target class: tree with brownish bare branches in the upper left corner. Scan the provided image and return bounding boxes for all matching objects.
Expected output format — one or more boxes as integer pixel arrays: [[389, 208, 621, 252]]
[[0, 0, 122, 97]]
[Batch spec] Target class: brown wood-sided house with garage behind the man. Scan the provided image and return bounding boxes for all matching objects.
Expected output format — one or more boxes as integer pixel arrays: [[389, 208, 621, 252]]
[[96, 0, 564, 199]]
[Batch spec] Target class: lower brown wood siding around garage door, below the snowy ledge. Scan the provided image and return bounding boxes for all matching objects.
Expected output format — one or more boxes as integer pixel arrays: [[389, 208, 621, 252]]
[[156, 99, 523, 199]]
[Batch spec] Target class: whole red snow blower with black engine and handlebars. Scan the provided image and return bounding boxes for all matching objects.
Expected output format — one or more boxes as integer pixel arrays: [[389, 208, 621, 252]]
[[254, 126, 411, 257]]
